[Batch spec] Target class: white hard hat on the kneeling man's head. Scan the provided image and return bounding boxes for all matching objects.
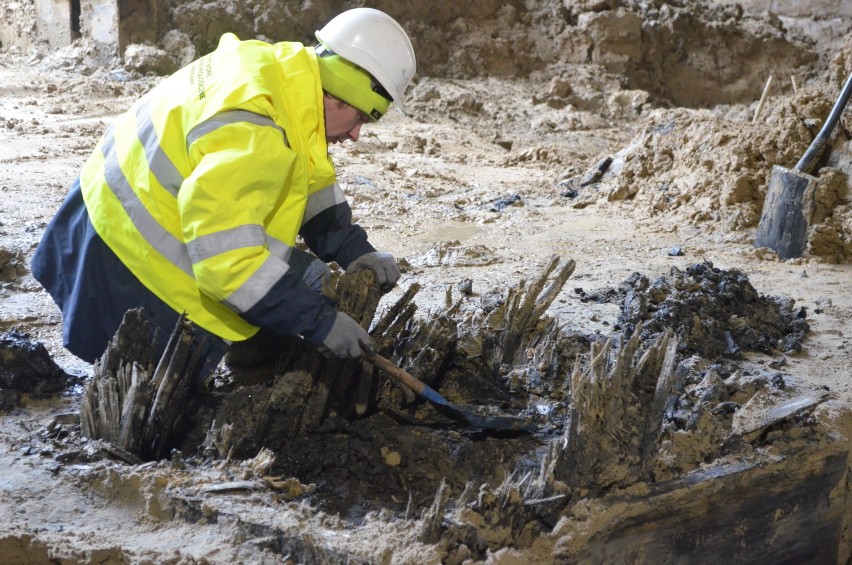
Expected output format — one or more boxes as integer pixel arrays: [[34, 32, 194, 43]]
[[316, 8, 417, 103]]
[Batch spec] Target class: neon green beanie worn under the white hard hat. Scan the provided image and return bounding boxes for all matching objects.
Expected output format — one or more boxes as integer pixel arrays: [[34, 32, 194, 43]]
[[317, 47, 391, 120]]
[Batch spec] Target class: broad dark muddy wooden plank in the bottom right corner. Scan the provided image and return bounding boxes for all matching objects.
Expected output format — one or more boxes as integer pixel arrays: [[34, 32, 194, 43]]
[[564, 442, 848, 563]]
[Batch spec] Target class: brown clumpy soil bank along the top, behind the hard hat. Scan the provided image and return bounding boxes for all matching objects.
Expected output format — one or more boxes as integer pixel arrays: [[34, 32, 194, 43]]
[[155, 0, 824, 107]]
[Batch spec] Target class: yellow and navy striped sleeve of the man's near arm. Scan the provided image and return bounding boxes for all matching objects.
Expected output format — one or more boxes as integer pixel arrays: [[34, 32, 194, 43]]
[[178, 117, 336, 343]]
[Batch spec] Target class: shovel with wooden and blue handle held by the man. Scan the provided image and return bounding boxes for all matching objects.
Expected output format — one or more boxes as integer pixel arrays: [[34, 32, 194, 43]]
[[365, 354, 536, 432]]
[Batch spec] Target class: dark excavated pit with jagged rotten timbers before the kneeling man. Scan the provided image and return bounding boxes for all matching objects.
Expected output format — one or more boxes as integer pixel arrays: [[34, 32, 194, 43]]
[[46, 258, 848, 562]]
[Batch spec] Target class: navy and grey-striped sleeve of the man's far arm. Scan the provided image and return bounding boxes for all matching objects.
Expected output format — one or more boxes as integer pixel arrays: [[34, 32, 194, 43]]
[[299, 183, 376, 269]]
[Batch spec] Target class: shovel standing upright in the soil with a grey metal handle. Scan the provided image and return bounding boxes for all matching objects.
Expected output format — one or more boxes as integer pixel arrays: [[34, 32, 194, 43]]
[[754, 71, 852, 259]]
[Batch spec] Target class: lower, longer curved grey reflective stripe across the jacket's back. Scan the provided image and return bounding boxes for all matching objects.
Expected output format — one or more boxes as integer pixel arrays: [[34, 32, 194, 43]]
[[101, 126, 194, 278]]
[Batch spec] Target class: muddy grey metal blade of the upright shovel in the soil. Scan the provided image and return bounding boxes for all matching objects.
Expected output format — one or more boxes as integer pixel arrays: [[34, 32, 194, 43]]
[[754, 165, 817, 259]]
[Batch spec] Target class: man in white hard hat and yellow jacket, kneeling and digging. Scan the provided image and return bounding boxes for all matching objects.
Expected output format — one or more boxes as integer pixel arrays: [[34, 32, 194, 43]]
[[32, 8, 415, 369]]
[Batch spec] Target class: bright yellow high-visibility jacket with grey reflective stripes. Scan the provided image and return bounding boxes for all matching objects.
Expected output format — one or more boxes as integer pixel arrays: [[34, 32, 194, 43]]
[[80, 34, 374, 340]]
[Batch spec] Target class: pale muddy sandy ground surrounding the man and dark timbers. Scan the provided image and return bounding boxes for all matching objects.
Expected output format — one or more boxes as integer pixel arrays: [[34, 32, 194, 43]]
[[0, 3, 852, 563]]
